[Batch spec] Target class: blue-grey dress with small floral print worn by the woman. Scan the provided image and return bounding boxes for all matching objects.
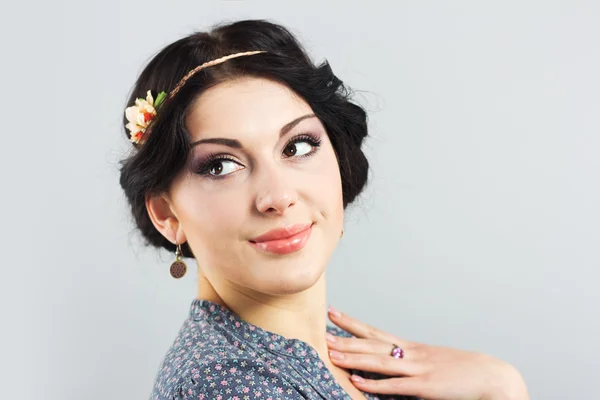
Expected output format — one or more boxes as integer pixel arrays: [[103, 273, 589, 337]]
[[150, 299, 412, 400]]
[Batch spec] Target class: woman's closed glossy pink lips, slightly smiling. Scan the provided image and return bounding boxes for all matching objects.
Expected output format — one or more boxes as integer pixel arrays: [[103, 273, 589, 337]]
[[249, 224, 312, 254]]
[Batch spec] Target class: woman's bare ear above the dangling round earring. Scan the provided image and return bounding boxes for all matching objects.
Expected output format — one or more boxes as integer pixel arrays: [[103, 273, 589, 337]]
[[146, 193, 187, 244]]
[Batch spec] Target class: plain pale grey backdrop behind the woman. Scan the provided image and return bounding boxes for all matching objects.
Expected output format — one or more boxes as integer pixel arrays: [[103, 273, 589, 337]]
[[0, 0, 600, 400]]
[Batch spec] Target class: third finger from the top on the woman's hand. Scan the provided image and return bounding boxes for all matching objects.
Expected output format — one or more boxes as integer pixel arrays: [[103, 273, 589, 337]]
[[329, 350, 424, 376]]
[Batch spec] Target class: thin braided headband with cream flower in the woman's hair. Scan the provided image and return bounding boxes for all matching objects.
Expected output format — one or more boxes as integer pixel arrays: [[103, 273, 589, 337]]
[[125, 50, 266, 144]]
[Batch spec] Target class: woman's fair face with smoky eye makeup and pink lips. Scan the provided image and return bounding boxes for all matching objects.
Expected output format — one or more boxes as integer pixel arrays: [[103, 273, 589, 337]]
[[169, 77, 344, 294]]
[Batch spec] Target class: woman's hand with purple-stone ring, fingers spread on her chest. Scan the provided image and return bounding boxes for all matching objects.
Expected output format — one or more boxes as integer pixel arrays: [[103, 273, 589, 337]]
[[328, 307, 529, 400]]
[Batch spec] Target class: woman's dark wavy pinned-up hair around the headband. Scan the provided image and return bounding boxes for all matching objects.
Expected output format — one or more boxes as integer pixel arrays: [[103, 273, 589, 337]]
[[120, 20, 369, 257]]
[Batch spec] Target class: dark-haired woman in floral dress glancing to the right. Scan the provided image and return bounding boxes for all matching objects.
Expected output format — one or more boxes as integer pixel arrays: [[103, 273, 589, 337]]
[[121, 20, 528, 400]]
